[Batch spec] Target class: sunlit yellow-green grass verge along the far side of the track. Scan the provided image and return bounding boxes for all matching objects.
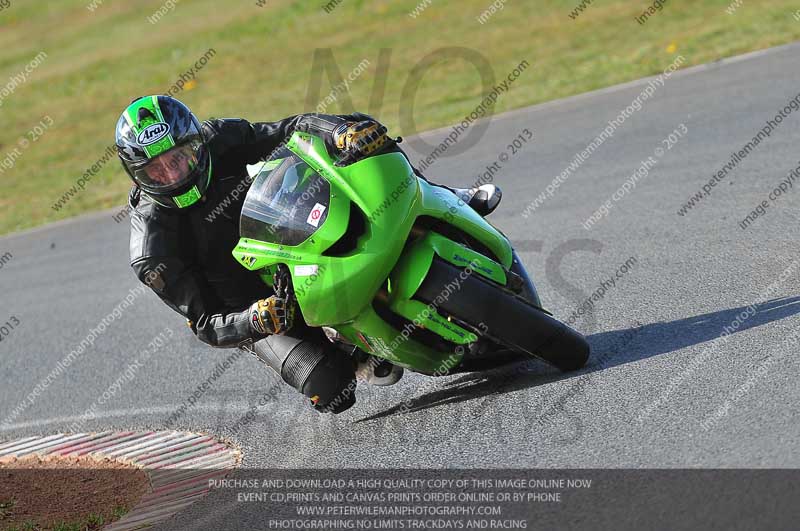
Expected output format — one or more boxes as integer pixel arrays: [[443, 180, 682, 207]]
[[0, 0, 800, 234]]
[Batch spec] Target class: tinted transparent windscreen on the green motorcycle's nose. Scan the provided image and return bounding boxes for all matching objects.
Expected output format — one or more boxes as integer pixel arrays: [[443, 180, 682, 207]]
[[239, 154, 331, 246]]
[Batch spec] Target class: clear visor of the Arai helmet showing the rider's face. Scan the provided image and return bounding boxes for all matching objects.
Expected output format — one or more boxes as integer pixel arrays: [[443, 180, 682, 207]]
[[131, 141, 203, 192]]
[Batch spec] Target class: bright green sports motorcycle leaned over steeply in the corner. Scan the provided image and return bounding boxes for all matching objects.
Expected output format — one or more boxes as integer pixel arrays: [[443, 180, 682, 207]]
[[233, 132, 589, 386]]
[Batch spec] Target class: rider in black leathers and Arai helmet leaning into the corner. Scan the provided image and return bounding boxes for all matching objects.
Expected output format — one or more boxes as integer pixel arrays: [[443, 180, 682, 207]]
[[116, 95, 501, 413]]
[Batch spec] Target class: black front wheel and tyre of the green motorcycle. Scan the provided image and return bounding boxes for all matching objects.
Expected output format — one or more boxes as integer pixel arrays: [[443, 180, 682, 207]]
[[414, 258, 590, 372]]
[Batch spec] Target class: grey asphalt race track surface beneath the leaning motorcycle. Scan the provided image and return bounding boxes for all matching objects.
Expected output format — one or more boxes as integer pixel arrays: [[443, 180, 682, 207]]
[[0, 45, 800, 526]]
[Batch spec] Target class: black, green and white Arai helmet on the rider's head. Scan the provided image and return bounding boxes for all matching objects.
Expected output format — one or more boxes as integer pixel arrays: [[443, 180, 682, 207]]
[[116, 96, 211, 208]]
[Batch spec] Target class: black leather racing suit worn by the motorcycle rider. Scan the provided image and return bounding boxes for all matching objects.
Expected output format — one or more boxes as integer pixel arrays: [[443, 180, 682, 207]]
[[130, 114, 412, 411]]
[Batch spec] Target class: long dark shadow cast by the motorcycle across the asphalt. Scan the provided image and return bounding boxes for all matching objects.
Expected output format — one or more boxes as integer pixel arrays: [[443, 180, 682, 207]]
[[356, 297, 800, 422]]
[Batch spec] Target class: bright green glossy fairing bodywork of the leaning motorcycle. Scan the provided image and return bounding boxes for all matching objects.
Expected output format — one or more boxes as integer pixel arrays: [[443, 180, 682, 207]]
[[233, 132, 512, 374]]
